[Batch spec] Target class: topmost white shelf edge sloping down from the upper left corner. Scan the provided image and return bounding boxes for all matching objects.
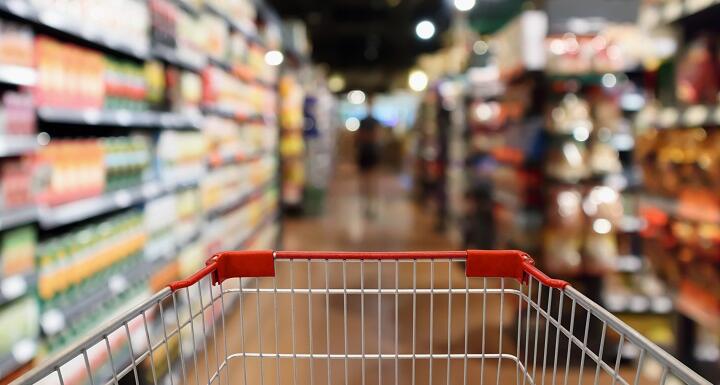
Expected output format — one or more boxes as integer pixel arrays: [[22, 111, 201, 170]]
[[0, 0, 148, 60]]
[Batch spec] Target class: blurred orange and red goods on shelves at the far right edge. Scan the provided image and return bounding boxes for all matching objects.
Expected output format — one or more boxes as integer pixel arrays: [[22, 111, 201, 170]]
[[636, 1, 720, 376]]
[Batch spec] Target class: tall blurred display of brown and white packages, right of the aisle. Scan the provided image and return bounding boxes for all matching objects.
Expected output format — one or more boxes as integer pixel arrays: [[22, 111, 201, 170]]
[[543, 25, 674, 357]]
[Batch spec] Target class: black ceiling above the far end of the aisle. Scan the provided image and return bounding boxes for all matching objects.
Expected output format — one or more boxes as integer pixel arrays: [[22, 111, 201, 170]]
[[269, 0, 452, 88]]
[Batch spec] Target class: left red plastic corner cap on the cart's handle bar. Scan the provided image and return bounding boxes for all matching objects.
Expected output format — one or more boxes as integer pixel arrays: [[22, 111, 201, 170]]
[[207, 250, 275, 284]]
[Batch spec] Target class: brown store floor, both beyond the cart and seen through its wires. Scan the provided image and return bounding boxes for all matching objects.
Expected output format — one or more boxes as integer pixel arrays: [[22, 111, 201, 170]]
[[186, 168, 652, 385]]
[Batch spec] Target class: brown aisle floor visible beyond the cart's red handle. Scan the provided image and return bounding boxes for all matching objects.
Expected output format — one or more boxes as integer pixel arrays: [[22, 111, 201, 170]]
[[283, 165, 453, 251]]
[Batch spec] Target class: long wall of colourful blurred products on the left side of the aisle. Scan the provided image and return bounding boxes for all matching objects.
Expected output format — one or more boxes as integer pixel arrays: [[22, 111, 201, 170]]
[[0, 0, 286, 382]]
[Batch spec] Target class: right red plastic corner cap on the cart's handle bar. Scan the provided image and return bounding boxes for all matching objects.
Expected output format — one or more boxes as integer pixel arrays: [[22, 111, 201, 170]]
[[465, 250, 528, 281]]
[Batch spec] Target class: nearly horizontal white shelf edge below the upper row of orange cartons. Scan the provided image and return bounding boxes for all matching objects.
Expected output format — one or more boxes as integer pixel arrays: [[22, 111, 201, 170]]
[[38, 107, 202, 129]]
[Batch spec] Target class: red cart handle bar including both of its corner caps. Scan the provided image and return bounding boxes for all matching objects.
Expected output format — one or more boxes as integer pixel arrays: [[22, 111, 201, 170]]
[[169, 250, 568, 291]]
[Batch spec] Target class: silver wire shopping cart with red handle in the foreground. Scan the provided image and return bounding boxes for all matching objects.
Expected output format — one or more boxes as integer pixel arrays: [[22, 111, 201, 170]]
[[16, 251, 710, 385]]
